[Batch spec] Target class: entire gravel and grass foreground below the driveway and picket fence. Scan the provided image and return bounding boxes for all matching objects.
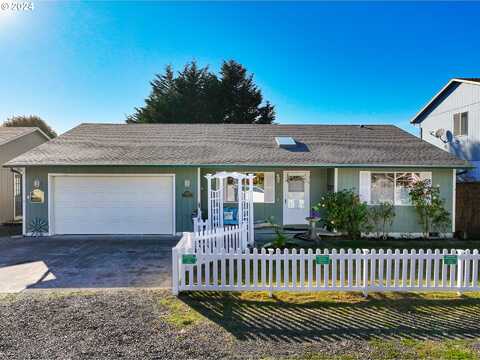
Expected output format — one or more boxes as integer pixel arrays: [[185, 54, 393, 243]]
[[0, 289, 480, 360]]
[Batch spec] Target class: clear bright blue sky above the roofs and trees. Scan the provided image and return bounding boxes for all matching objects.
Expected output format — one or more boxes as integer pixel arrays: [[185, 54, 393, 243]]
[[0, 1, 480, 133]]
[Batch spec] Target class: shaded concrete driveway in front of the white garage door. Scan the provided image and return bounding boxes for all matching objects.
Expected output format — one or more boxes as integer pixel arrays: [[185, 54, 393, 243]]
[[0, 235, 178, 292]]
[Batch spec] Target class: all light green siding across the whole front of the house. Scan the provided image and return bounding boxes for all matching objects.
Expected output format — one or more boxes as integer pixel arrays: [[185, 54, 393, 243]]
[[26, 166, 453, 233]]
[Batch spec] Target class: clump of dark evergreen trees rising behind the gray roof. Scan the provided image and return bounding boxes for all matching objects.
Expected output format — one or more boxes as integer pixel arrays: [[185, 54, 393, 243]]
[[127, 60, 275, 124]]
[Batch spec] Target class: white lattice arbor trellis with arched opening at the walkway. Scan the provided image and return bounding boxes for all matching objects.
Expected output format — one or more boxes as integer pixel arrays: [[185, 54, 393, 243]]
[[194, 171, 255, 245]]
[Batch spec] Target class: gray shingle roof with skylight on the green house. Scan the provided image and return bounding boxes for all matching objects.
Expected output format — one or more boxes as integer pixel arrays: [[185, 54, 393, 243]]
[[2, 124, 469, 167]]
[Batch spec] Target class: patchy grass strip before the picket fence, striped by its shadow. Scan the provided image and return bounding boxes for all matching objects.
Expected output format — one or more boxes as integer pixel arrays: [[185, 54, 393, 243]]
[[175, 292, 480, 360]]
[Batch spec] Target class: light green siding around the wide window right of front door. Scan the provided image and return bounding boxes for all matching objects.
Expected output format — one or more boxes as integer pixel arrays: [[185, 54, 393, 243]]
[[338, 168, 453, 233]]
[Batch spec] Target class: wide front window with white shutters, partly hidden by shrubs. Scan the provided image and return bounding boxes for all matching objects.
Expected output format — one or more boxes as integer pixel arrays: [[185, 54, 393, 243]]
[[359, 171, 432, 205]]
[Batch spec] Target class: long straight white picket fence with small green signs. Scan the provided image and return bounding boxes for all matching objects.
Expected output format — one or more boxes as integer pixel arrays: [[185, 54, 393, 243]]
[[173, 246, 480, 294]]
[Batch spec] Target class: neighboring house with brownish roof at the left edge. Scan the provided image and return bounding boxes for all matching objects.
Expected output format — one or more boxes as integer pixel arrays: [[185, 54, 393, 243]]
[[0, 126, 50, 225]]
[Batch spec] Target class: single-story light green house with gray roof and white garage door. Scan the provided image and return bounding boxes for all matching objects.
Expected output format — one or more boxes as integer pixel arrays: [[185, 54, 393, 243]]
[[1, 124, 471, 235]]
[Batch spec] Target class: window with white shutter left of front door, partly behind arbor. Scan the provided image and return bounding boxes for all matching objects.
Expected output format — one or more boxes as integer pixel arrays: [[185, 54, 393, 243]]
[[223, 172, 275, 203]]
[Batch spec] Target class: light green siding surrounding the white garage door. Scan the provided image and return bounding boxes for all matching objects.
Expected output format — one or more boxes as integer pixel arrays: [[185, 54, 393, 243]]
[[26, 166, 197, 232]]
